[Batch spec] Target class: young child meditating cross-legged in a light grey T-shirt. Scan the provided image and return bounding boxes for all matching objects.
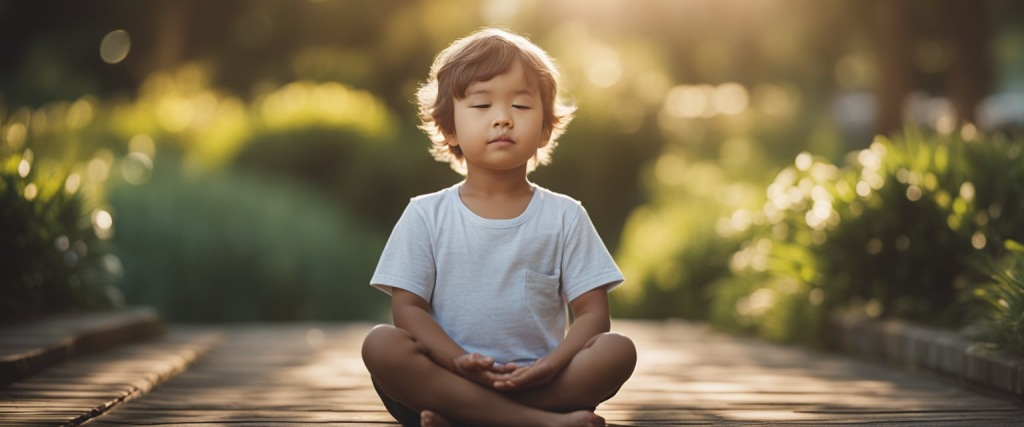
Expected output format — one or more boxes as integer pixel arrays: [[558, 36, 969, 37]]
[[362, 29, 636, 426]]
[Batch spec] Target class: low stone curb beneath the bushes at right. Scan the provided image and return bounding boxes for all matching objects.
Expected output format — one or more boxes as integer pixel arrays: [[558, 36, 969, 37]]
[[827, 312, 1024, 403]]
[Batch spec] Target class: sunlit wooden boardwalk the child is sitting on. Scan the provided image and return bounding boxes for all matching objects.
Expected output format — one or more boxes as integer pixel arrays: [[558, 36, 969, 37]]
[[8, 322, 1024, 427]]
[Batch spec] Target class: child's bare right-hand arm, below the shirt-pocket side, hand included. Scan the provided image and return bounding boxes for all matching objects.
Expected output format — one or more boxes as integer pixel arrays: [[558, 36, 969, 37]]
[[495, 287, 611, 391]]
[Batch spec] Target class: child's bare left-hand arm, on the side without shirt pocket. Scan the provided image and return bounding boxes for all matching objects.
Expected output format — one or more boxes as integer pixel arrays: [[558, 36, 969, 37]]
[[391, 288, 514, 386]]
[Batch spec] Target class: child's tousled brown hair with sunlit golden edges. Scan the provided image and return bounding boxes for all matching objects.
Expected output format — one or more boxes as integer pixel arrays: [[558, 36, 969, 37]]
[[417, 28, 575, 175]]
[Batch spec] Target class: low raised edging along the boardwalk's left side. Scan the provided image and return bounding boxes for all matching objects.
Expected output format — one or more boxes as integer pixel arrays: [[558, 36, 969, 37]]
[[0, 307, 164, 386]]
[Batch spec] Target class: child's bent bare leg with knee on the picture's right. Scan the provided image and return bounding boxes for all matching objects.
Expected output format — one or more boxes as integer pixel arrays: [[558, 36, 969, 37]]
[[507, 333, 637, 412]]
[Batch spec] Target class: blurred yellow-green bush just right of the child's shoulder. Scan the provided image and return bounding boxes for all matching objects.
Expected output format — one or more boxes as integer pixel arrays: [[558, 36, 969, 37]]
[[610, 153, 757, 318]]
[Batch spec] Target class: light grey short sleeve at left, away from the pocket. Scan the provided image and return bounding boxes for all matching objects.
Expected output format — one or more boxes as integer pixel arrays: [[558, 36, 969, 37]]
[[370, 202, 436, 301]]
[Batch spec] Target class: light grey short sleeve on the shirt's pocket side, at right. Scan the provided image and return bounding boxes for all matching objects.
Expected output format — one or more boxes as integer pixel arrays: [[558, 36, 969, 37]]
[[561, 205, 625, 301]]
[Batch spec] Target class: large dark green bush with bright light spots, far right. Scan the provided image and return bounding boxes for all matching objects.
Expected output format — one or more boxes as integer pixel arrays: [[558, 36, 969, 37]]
[[715, 126, 1024, 341]]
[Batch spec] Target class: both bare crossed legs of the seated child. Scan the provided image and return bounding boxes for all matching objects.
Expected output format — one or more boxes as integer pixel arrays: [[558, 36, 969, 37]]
[[362, 325, 636, 426]]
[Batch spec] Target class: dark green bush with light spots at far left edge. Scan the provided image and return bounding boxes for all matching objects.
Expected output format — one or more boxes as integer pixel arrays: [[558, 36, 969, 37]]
[[0, 145, 123, 323]]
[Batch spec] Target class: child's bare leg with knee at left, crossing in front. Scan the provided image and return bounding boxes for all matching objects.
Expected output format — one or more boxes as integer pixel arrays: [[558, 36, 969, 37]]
[[362, 325, 604, 426]]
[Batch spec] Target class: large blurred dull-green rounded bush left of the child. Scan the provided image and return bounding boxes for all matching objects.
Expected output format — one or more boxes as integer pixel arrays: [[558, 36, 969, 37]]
[[110, 157, 388, 322]]
